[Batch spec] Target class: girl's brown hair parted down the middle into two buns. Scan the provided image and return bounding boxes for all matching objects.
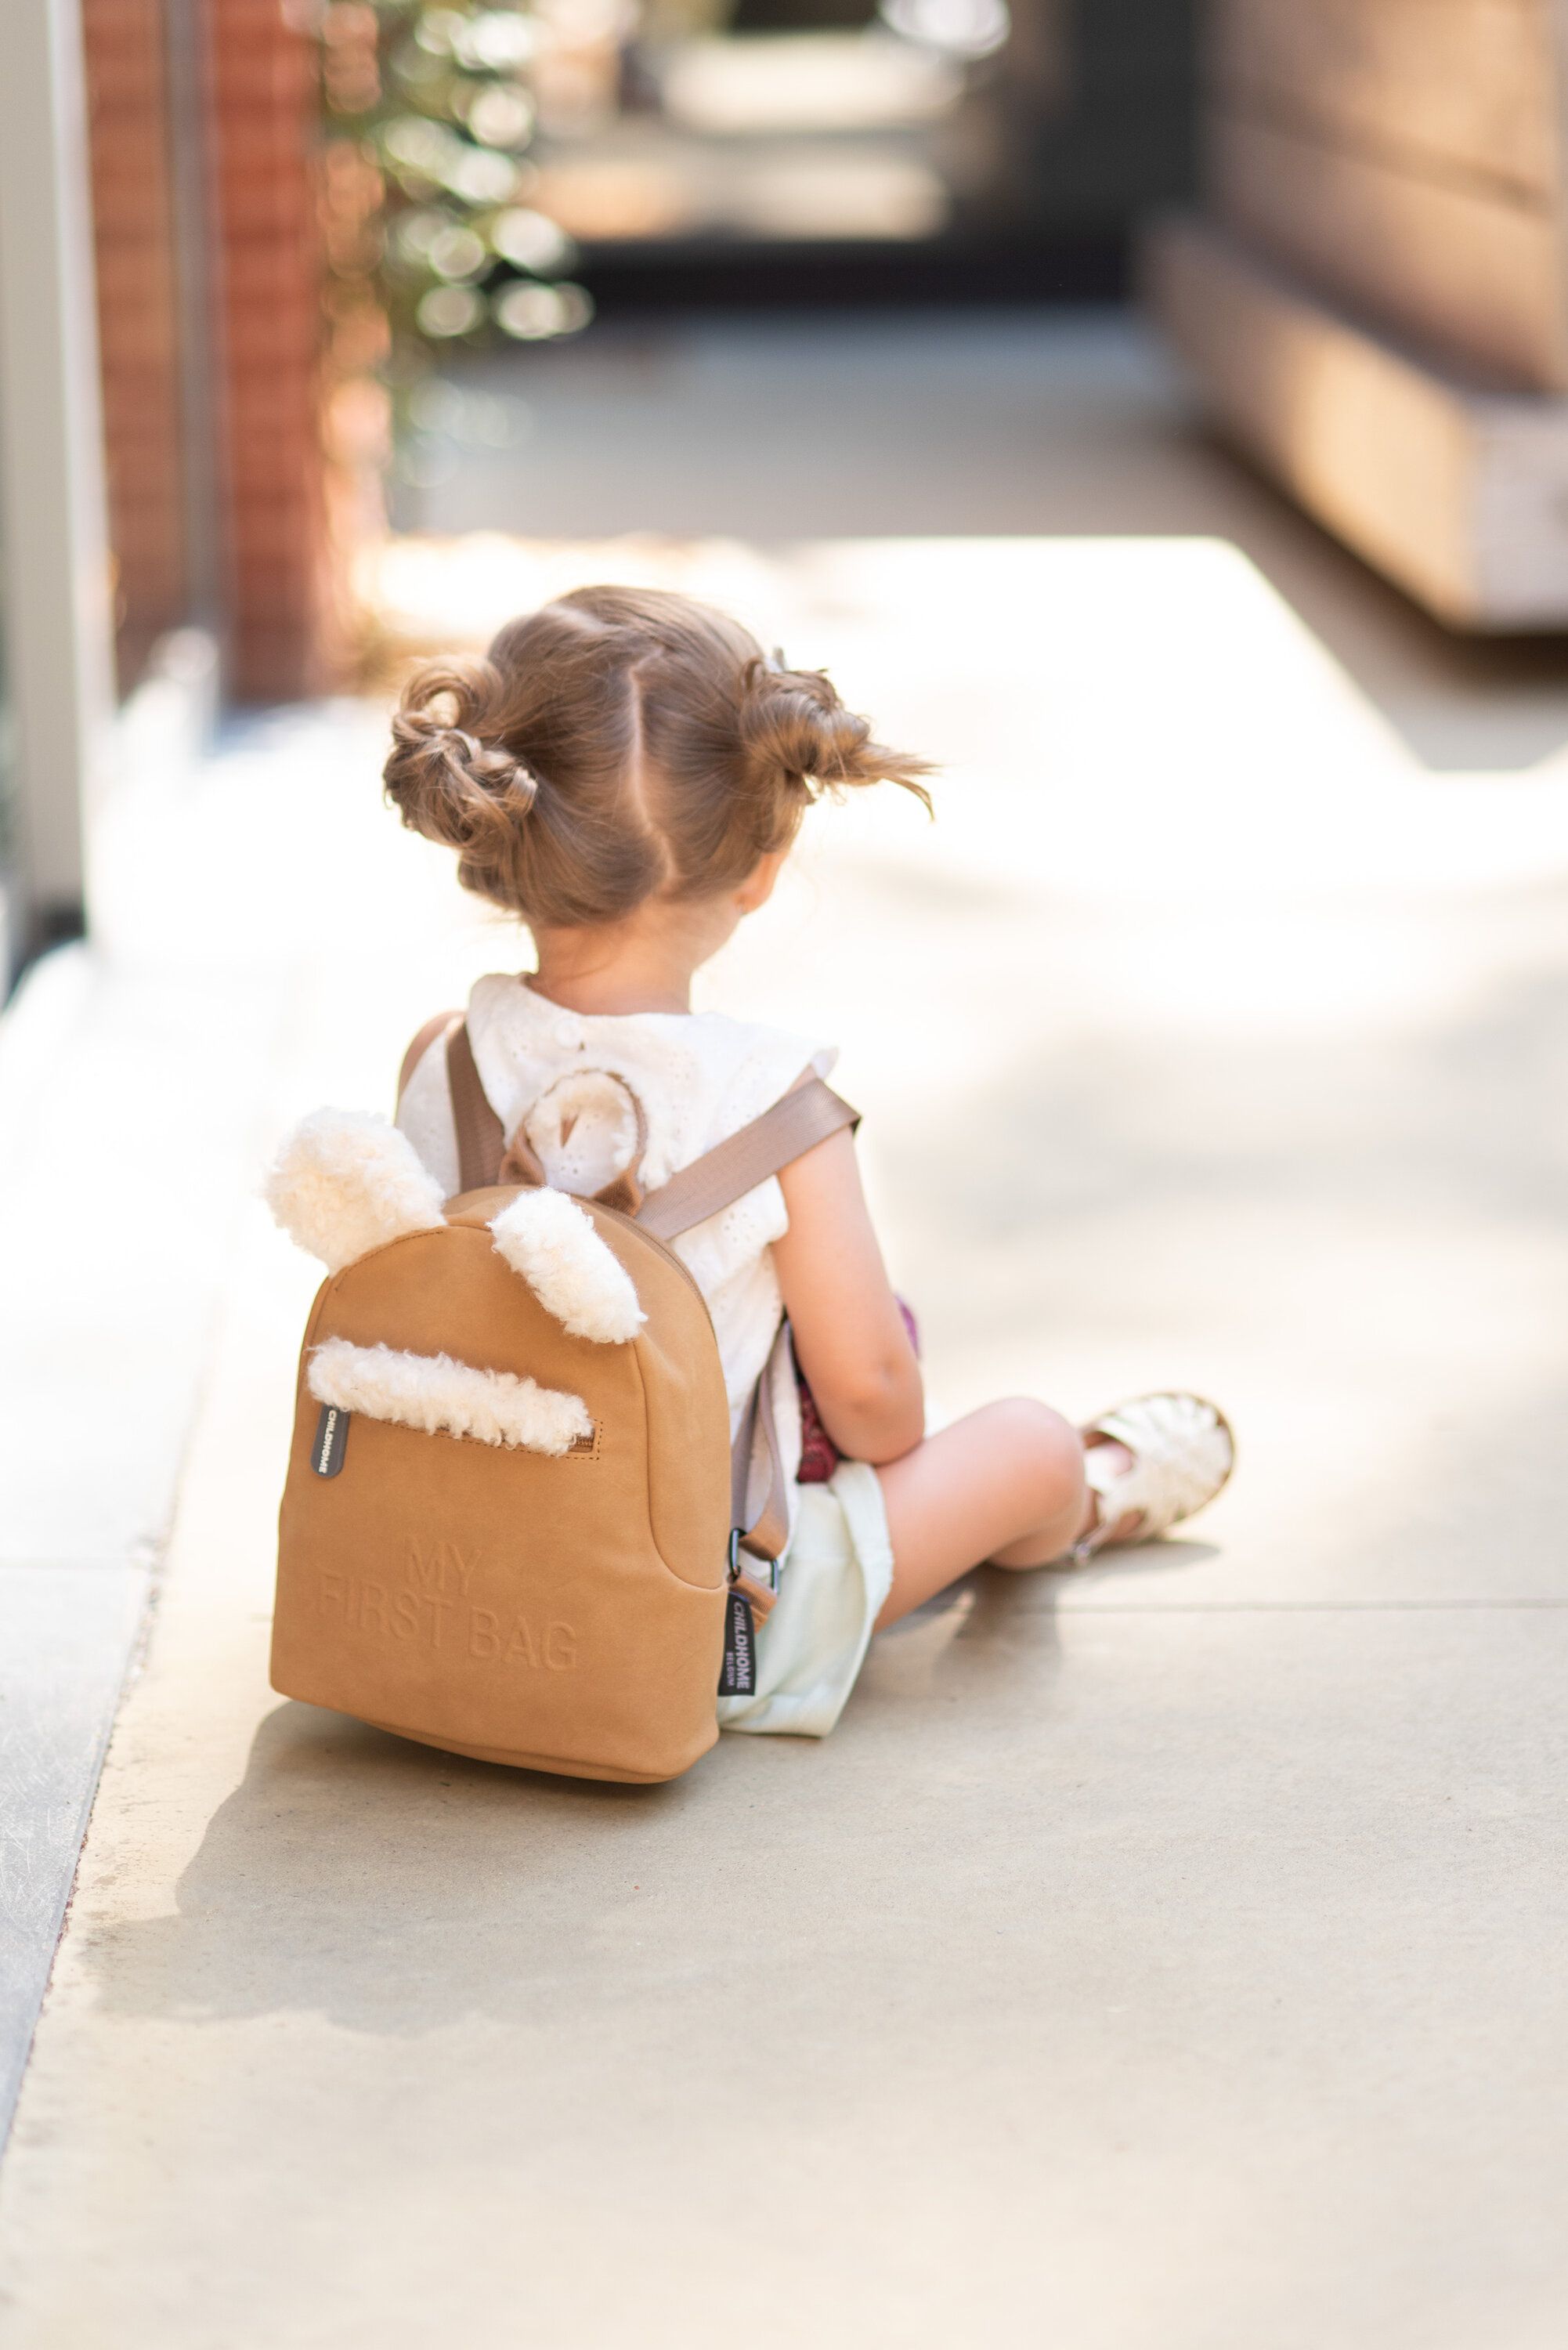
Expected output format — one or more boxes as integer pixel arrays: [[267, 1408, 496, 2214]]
[[385, 588, 931, 928]]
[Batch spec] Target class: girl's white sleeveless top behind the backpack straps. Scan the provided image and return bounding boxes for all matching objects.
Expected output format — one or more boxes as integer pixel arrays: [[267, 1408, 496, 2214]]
[[397, 973, 840, 1495]]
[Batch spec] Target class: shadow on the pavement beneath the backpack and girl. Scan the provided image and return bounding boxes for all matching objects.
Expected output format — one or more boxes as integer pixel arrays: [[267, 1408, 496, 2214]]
[[85, 1544, 1211, 2037]]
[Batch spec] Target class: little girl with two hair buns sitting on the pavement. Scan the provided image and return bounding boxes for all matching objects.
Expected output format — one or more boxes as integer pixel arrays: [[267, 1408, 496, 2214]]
[[385, 588, 1232, 1737]]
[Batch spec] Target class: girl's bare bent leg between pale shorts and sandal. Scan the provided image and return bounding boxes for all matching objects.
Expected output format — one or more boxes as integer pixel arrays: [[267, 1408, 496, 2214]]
[[877, 1398, 1096, 1631]]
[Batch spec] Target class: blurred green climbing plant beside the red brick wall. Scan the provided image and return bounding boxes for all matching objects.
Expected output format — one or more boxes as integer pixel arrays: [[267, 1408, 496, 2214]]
[[320, 0, 592, 367]]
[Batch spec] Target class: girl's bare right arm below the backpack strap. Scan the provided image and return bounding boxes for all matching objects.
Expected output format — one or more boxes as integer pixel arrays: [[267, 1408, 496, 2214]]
[[773, 1133, 927, 1462]]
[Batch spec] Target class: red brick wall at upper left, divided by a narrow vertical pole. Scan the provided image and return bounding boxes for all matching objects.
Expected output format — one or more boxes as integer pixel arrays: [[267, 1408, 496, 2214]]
[[82, 0, 336, 700]]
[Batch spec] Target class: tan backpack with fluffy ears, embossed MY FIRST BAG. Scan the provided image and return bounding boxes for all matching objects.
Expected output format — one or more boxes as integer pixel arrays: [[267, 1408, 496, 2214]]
[[268, 1018, 856, 1779]]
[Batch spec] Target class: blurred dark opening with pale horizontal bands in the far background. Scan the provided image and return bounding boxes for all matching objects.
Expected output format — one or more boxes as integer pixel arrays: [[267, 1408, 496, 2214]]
[[540, 0, 1197, 306]]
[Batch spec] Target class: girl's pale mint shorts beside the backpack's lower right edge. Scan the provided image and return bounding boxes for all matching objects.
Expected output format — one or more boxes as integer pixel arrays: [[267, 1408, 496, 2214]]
[[719, 1462, 894, 1739]]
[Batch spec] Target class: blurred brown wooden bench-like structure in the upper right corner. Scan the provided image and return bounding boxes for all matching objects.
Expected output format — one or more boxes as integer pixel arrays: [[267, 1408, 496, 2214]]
[[1145, 0, 1568, 630]]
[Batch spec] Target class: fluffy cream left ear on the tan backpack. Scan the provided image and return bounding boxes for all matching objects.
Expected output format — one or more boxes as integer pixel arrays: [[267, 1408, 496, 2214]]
[[263, 1109, 444, 1274]]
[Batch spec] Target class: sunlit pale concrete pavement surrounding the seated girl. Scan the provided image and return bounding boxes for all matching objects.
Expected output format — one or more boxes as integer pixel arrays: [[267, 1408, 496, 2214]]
[[0, 317, 1568, 2350]]
